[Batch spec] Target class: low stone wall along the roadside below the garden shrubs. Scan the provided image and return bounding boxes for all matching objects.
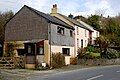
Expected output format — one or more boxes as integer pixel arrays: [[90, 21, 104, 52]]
[[77, 59, 120, 65]]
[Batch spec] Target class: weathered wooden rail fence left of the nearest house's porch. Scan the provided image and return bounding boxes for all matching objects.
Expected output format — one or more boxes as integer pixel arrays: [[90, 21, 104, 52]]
[[0, 57, 25, 69]]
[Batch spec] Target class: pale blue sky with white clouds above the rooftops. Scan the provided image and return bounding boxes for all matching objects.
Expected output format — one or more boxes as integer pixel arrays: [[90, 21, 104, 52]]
[[0, 0, 120, 17]]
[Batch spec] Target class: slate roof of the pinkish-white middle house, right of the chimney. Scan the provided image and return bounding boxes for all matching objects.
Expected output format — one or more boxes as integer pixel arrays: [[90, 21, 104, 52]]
[[58, 13, 93, 31]]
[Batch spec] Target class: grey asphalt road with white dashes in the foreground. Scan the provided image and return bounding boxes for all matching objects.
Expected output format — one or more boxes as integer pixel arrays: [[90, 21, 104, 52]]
[[28, 65, 120, 80]]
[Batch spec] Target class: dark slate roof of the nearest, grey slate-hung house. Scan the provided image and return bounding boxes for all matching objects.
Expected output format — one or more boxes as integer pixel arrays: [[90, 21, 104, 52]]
[[24, 5, 74, 29]]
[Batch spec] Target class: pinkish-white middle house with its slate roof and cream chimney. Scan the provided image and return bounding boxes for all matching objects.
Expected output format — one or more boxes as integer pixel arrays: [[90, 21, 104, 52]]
[[51, 4, 94, 57]]
